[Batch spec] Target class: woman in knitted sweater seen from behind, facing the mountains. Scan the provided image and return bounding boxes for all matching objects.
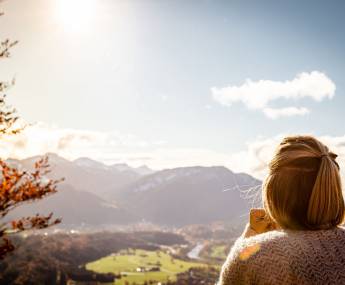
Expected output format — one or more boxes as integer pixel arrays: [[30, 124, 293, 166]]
[[218, 136, 345, 285]]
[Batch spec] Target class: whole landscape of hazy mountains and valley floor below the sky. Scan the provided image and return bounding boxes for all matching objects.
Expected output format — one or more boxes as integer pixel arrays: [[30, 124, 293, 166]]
[[0, 153, 261, 285]]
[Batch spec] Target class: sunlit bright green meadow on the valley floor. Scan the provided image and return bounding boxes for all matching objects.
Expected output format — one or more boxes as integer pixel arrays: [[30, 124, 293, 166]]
[[86, 249, 206, 285]]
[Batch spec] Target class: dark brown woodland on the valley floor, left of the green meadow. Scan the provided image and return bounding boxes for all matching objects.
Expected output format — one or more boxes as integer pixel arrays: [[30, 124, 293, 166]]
[[0, 230, 186, 285]]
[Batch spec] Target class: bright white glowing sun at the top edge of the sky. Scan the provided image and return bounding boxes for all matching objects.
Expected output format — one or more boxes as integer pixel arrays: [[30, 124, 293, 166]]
[[54, 0, 98, 32]]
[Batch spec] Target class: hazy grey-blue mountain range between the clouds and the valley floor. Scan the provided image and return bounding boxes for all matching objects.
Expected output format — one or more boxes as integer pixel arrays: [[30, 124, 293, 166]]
[[9, 153, 261, 226]]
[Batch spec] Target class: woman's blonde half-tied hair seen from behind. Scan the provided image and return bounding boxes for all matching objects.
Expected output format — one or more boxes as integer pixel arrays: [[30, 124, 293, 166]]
[[262, 136, 345, 230]]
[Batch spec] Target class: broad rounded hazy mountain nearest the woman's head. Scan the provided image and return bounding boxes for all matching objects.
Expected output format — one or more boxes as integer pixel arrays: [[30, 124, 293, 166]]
[[116, 166, 261, 226]]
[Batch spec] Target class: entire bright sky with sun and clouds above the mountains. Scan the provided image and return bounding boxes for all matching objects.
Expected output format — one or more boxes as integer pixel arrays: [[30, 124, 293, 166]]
[[0, 0, 345, 177]]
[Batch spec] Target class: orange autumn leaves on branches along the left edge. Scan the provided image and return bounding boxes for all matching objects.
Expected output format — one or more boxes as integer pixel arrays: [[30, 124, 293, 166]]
[[0, 14, 60, 259]]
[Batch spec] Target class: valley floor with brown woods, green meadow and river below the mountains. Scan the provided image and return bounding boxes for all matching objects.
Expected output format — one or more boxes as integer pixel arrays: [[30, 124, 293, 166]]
[[0, 227, 237, 285]]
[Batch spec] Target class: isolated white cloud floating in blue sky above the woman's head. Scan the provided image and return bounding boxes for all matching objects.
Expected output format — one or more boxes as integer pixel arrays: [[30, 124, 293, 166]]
[[211, 71, 336, 119]]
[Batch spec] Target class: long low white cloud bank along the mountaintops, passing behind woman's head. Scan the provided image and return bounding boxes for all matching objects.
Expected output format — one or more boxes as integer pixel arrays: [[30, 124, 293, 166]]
[[0, 123, 345, 179]]
